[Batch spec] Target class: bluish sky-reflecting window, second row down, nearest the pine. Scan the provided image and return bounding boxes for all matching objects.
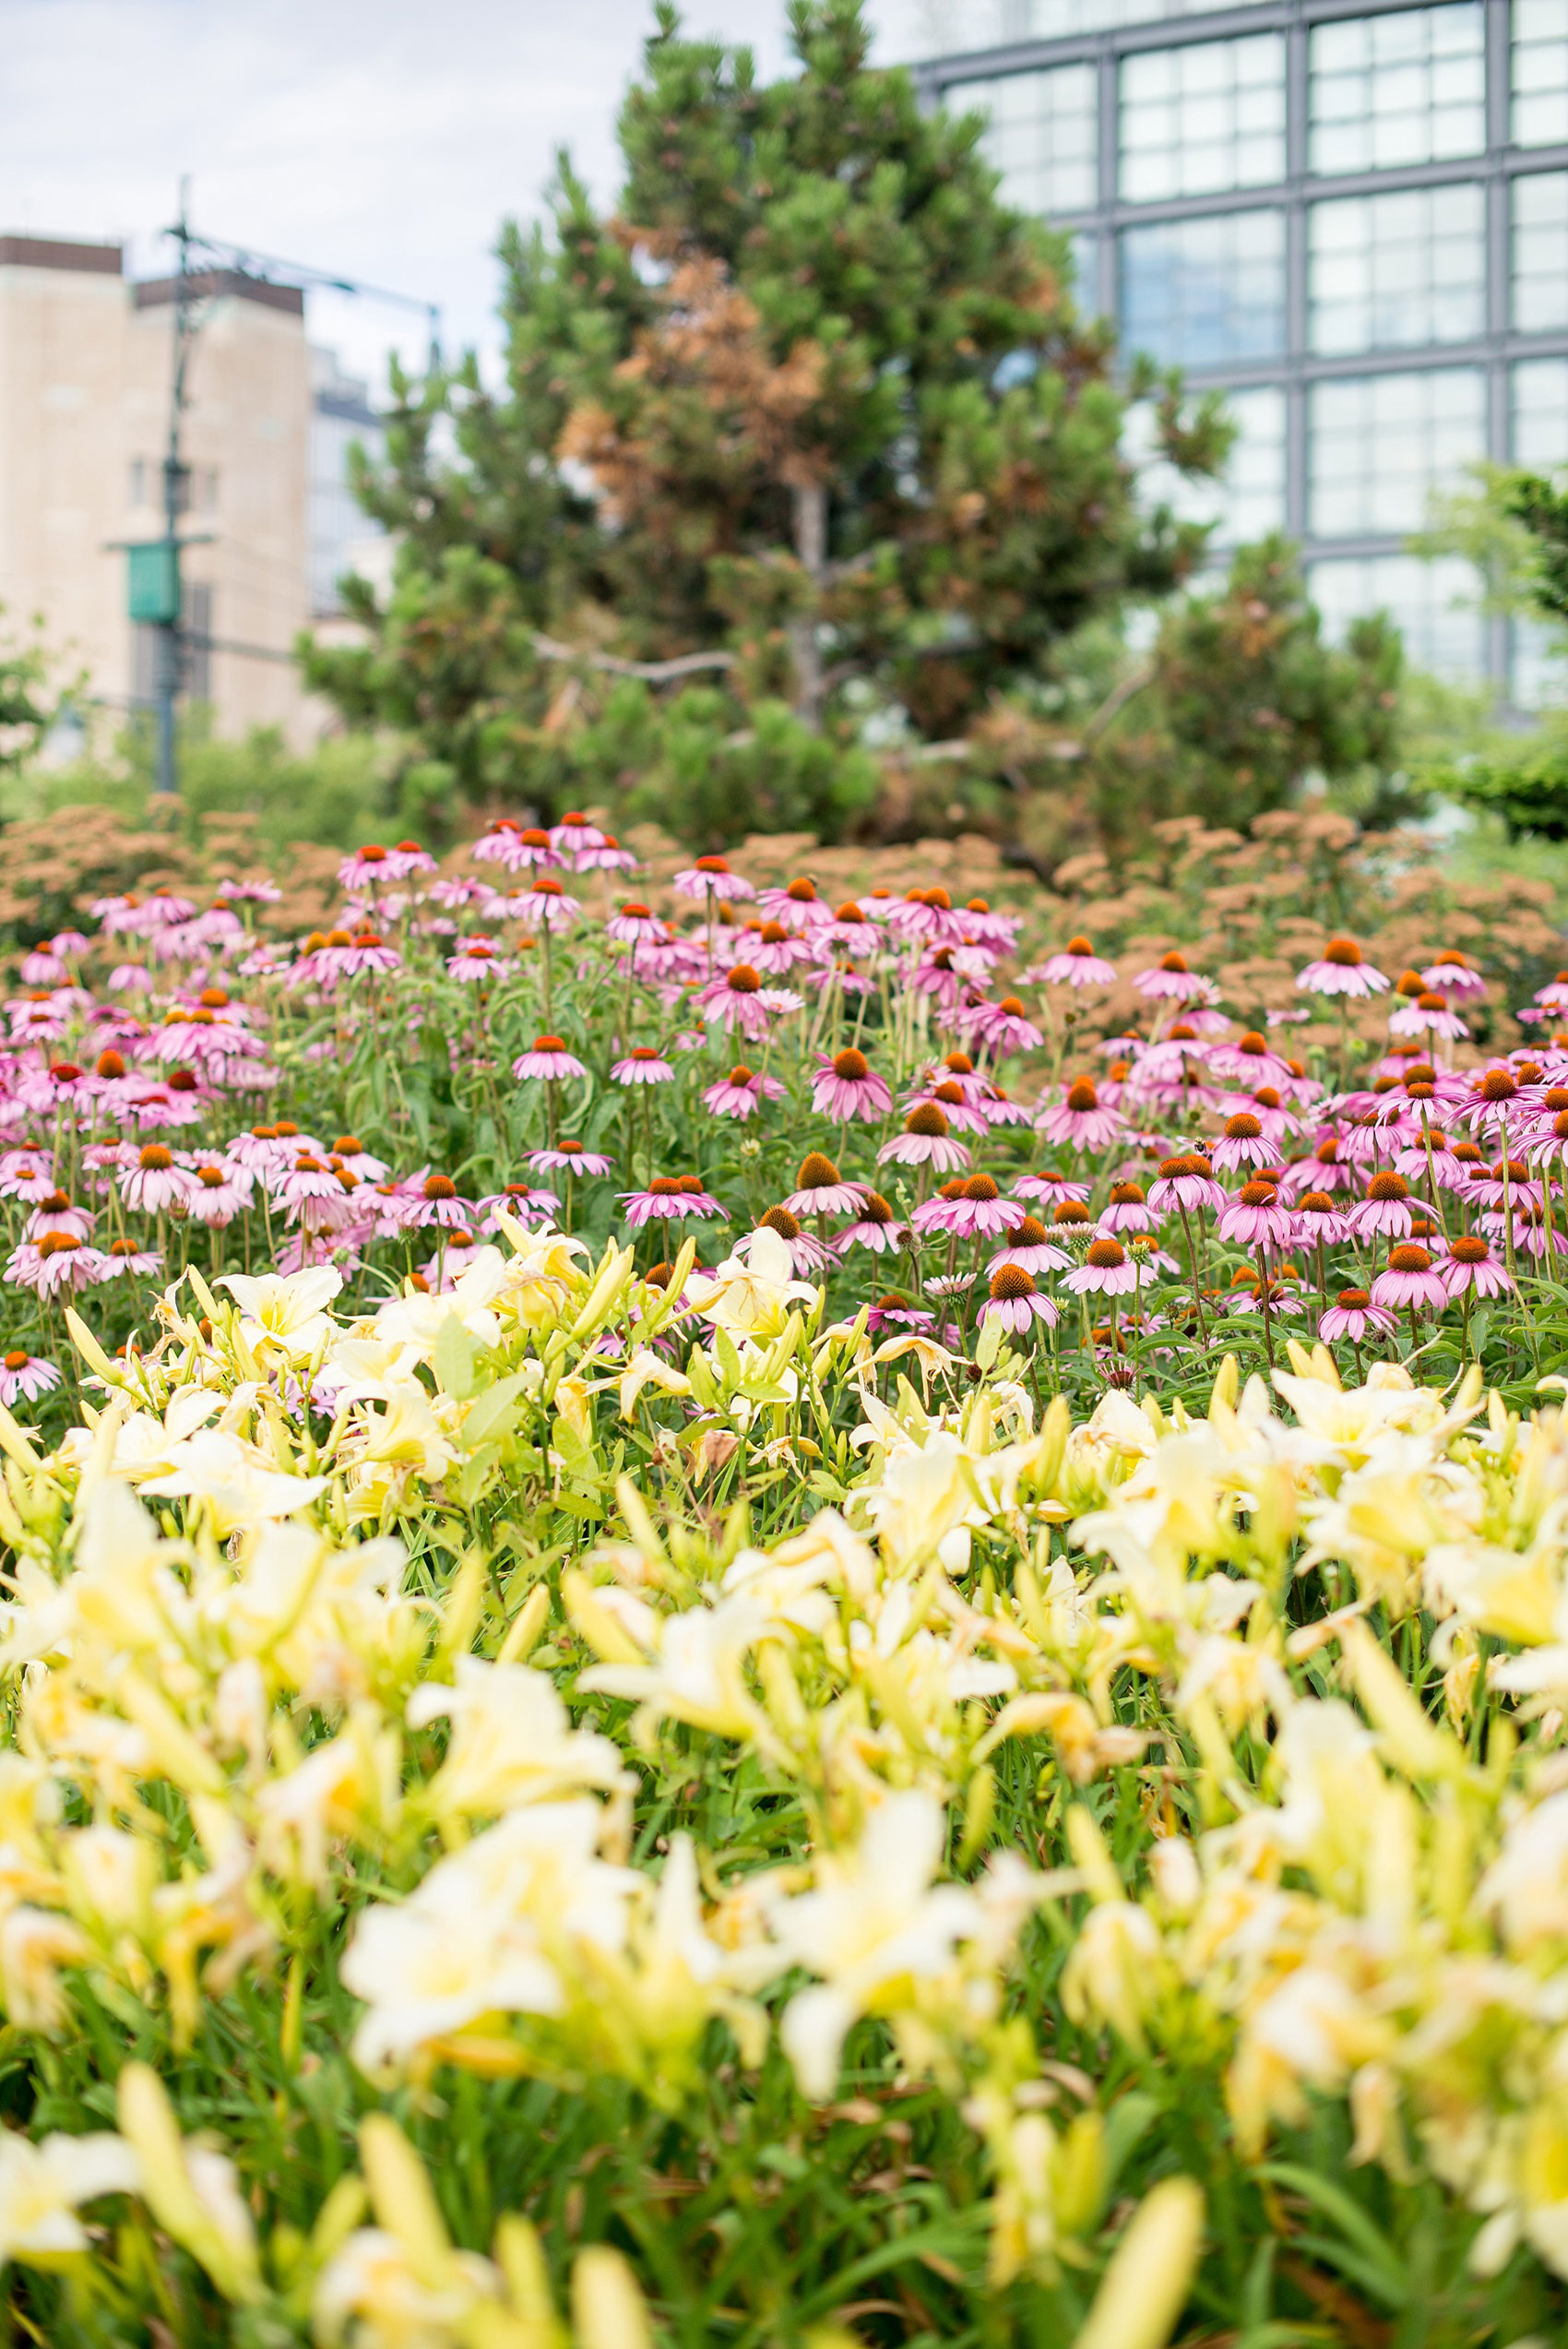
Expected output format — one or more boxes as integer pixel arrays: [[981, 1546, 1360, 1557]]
[[1120, 211, 1284, 366]]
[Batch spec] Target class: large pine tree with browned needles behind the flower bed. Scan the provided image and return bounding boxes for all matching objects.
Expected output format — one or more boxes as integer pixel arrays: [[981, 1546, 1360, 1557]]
[[305, 0, 1230, 846]]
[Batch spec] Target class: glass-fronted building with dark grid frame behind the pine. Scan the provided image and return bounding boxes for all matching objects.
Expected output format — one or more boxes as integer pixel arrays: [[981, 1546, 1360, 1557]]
[[921, 0, 1568, 702]]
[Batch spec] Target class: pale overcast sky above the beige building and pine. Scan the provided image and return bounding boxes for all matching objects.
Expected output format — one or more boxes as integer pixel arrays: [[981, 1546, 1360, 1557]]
[[0, 0, 998, 378]]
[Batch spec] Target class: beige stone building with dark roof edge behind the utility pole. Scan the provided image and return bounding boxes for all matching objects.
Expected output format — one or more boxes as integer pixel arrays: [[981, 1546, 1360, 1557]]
[[0, 235, 375, 743]]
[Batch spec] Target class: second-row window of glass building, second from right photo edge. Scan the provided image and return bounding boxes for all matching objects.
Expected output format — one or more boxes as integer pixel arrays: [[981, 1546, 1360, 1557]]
[[1308, 181, 1486, 352]]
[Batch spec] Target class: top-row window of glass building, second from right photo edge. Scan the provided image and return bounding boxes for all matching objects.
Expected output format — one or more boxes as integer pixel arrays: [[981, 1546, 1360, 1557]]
[[1308, 0, 1486, 172]]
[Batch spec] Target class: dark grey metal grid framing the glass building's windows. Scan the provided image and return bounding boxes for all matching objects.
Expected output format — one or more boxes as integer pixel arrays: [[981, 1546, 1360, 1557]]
[[916, 0, 1568, 688]]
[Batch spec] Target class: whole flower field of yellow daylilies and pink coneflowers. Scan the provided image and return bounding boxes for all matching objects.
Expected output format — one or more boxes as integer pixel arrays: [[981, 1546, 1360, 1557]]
[[0, 817, 1568, 2349]]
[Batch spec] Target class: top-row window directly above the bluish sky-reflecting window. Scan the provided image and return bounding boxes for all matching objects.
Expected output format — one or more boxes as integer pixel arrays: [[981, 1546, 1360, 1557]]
[[1117, 33, 1284, 205]]
